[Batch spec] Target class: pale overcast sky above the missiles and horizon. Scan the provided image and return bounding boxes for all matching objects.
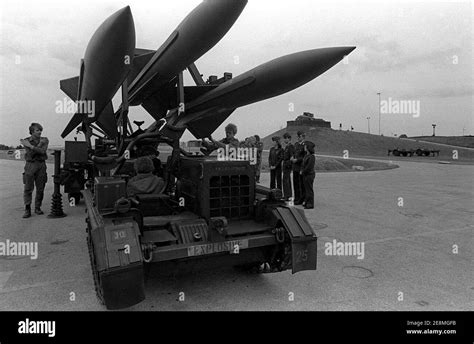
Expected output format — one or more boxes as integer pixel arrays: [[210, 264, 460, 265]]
[[0, 0, 474, 145]]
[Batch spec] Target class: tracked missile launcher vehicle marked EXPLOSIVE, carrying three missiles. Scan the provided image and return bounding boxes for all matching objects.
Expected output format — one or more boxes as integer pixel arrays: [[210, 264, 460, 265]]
[[55, 0, 355, 309]]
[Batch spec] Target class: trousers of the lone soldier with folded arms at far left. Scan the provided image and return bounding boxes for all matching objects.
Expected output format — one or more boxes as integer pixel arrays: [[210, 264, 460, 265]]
[[23, 161, 48, 208]]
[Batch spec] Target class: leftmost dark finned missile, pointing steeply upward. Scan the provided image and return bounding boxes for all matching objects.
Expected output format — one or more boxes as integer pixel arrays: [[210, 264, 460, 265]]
[[60, 6, 135, 138]]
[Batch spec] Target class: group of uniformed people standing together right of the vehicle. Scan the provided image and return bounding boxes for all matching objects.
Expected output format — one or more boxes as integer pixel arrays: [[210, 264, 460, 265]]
[[268, 131, 316, 209]]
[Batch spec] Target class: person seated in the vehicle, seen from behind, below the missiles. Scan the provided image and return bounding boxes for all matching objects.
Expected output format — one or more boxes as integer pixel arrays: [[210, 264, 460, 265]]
[[127, 157, 165, 197]]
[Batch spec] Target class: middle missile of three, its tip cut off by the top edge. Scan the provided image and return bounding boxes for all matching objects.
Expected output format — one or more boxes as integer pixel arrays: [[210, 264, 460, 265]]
[[128, 0, 247, 106]]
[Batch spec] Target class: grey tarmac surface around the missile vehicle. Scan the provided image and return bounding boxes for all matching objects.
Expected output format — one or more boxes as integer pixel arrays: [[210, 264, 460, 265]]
[[0, 160, 474, 311]]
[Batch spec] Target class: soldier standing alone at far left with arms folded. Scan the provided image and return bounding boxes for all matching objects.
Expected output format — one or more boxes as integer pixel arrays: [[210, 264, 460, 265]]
[[20, 123, 49, 219]]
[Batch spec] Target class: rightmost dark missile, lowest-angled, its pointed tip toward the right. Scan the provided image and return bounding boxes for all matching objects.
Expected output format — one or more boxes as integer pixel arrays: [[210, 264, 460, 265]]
[[168, 47, 355, 137]]
